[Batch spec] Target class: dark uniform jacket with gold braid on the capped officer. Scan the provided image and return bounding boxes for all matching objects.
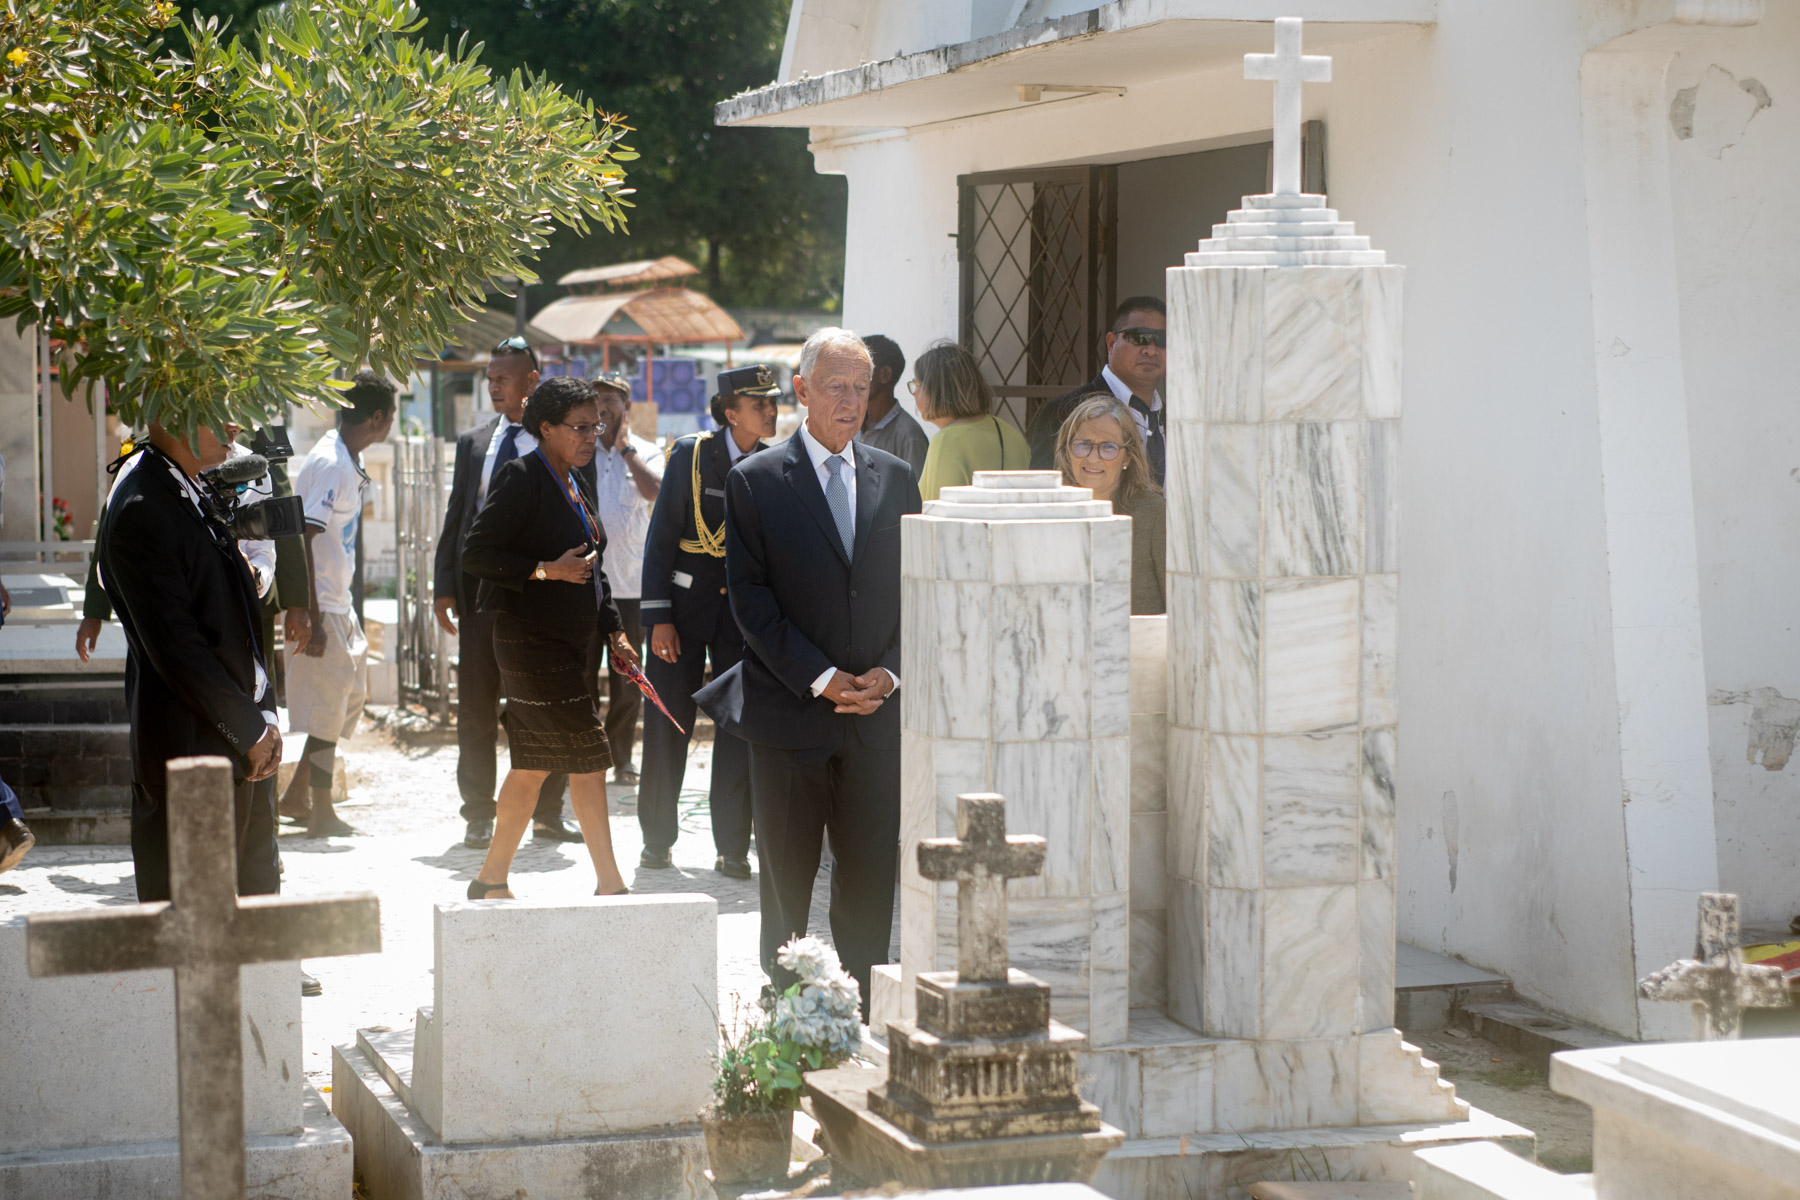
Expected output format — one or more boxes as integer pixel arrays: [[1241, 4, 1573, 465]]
[[639, 430, 763, 642]]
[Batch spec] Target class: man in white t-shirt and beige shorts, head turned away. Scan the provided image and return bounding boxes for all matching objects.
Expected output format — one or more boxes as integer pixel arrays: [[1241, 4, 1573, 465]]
[[281, 371, 394, 838]]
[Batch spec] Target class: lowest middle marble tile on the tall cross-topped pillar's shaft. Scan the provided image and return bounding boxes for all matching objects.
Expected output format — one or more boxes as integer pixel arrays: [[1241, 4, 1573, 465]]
[[1262, 885, 1361, 1038]]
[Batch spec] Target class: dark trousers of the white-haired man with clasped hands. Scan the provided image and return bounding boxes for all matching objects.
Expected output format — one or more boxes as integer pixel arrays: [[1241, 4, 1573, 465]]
[[751, 721, 900, 1020]]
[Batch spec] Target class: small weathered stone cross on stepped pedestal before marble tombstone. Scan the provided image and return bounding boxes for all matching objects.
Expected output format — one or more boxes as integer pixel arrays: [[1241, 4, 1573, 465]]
[[918, 793, 1048, 984]]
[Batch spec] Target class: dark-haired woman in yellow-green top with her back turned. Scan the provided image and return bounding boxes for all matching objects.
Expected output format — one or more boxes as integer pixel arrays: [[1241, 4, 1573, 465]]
[[907, 342, 1031, 500]]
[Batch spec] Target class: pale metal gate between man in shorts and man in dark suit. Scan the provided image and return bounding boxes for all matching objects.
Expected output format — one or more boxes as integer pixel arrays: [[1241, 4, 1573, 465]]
[[394, 437, 452, 720]]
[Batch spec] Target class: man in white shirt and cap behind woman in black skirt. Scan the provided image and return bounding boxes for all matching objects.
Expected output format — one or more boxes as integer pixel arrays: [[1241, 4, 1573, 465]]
[[594, 374, 662, 784]]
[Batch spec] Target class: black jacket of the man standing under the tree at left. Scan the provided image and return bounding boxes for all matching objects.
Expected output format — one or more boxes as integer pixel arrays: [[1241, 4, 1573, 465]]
[[95, 450, 275, 793]]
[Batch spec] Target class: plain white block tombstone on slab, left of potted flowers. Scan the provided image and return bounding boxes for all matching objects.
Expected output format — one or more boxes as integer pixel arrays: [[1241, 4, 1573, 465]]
[[331, 894, 718, 1200]]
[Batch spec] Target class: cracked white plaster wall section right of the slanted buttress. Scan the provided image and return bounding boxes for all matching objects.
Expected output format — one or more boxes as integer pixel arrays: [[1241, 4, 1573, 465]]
[[1669, 4, 1800, 925]]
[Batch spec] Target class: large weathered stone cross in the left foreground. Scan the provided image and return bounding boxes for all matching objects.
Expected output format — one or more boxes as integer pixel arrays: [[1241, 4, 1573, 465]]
[[25, 757, 382, 1200]]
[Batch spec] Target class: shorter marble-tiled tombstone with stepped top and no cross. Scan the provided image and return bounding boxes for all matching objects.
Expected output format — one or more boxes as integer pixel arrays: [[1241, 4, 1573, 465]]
[[892, 471, 1130, 1045]]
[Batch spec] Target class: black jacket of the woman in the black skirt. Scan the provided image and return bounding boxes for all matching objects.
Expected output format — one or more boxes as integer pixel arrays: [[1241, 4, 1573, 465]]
[[463, 453, 625, 633]]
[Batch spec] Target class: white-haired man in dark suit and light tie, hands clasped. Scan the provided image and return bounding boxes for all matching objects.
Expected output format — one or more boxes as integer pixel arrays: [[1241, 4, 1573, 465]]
[[697, 329, 920, 1016]]
